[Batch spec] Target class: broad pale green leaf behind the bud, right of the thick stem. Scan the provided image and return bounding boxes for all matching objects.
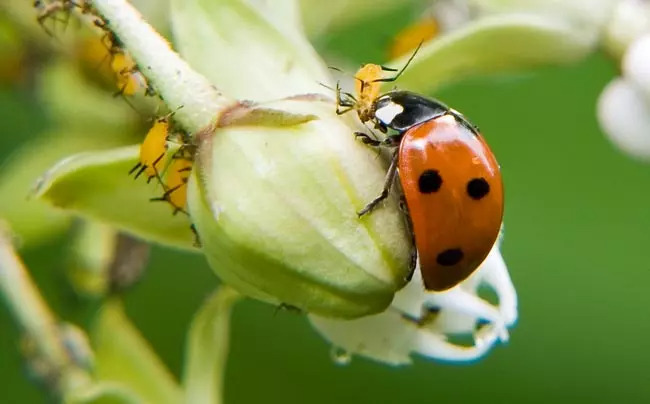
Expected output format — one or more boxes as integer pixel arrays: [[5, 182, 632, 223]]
[[172, 0, 331, 101]]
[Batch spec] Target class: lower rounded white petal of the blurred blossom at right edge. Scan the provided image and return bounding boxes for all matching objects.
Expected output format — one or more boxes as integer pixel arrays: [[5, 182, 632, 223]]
[[598, 78, 650, 160]]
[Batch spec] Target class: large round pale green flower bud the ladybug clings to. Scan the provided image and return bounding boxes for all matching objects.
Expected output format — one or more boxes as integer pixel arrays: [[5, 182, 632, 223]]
[[188, 96, 411, 318]]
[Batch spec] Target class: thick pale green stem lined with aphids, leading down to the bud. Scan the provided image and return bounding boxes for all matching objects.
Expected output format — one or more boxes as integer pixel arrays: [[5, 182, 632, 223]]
[[92, 0, 234, 132]]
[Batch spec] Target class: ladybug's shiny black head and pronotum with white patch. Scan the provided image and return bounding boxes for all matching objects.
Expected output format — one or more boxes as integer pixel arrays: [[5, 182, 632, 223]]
[[373, 91, 449, 133]]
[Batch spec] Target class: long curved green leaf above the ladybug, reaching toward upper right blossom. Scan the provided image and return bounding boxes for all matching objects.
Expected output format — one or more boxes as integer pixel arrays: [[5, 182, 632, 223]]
[[387, 14, 594, 92]]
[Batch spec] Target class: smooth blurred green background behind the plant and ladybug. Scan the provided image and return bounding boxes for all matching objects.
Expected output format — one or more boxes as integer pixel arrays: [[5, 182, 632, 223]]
[[0, 3, 650, 403]]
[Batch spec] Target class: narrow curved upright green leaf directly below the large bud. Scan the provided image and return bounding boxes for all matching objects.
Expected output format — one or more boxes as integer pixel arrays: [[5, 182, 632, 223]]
[[183, 286, 241, 404]]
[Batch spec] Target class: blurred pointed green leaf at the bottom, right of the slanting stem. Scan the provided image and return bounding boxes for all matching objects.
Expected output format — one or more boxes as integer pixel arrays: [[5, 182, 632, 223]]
[[91, 299, 182, 404]]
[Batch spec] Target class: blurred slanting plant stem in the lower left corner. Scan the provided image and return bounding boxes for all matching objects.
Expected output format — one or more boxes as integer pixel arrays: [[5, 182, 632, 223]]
[[0, 223, 90, 394]]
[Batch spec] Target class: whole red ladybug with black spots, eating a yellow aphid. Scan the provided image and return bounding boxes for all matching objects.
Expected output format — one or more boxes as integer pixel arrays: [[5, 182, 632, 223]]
[[338, 59, 504, 291]]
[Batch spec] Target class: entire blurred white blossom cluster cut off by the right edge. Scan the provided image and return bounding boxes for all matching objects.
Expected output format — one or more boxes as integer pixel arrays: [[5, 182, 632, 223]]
[[597, 0, 650, 160]]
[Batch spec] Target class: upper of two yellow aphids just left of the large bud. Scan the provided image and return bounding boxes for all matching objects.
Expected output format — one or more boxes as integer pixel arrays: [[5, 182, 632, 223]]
[[129, 116, 169, 182]]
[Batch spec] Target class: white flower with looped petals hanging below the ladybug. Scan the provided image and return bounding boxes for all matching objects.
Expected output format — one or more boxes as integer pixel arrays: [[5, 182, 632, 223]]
[[309, 243, 517, 365]]
